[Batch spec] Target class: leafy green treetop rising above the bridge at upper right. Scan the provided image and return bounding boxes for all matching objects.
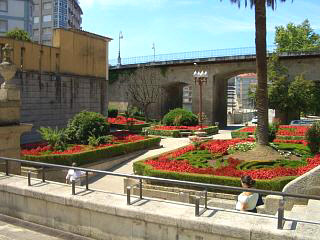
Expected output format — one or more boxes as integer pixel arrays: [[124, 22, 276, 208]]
[[275, 19, 320, 52]]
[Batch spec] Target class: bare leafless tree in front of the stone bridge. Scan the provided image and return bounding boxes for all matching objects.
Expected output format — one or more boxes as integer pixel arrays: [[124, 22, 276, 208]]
[[123, 67, 162, 121]]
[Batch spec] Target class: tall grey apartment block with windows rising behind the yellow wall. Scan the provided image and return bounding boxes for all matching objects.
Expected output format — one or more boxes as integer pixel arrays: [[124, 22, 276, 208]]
[[33, 0, 82, 46]]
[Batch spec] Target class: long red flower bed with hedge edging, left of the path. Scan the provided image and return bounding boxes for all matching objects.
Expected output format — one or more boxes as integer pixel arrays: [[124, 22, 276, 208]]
[[21, 133, 161, 165]]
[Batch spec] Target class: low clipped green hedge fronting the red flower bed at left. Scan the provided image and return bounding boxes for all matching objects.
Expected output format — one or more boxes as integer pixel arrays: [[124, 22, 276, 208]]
[[23, 137, 161, 166]]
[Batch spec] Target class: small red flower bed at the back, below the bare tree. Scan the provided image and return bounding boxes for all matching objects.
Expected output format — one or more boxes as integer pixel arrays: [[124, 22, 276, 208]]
[[107, 116, 150, 132]]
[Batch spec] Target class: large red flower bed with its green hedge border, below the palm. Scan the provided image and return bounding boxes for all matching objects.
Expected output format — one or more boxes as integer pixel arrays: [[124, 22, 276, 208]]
[[134, 139, 320, 191]]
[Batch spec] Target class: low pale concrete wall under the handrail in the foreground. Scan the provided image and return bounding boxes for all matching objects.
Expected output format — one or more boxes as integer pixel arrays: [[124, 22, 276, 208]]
[[0, 176, 320, 240]]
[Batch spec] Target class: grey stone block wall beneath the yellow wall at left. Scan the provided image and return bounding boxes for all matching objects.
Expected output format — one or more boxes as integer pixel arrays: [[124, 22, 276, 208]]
[[0, 71, 107, 143]]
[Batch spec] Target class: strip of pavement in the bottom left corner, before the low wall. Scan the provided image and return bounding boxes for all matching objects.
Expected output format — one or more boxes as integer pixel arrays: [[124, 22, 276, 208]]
[[0, 214, 92, 240]]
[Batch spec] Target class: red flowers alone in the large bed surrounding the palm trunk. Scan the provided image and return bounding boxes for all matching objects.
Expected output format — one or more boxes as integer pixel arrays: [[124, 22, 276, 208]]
[[145, 139, 320, 179]]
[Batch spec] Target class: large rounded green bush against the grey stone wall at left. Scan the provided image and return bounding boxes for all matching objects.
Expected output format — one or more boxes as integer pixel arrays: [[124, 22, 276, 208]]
[[65, 111, 109, 145]]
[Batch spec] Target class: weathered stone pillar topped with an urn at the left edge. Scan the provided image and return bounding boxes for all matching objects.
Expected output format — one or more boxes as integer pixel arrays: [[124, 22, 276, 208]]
[[0, 44, 32, 174]]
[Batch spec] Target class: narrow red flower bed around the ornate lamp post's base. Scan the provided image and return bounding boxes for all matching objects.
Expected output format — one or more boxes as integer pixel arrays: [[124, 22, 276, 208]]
[[144, 126, 219, 137]]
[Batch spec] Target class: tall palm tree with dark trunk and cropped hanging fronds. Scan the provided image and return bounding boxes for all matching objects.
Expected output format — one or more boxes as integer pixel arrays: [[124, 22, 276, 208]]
[[225, 0, 293, 146]]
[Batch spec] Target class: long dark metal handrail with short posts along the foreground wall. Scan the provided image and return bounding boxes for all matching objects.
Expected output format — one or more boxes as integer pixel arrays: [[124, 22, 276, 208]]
[[0, 157, 320, 229]]
